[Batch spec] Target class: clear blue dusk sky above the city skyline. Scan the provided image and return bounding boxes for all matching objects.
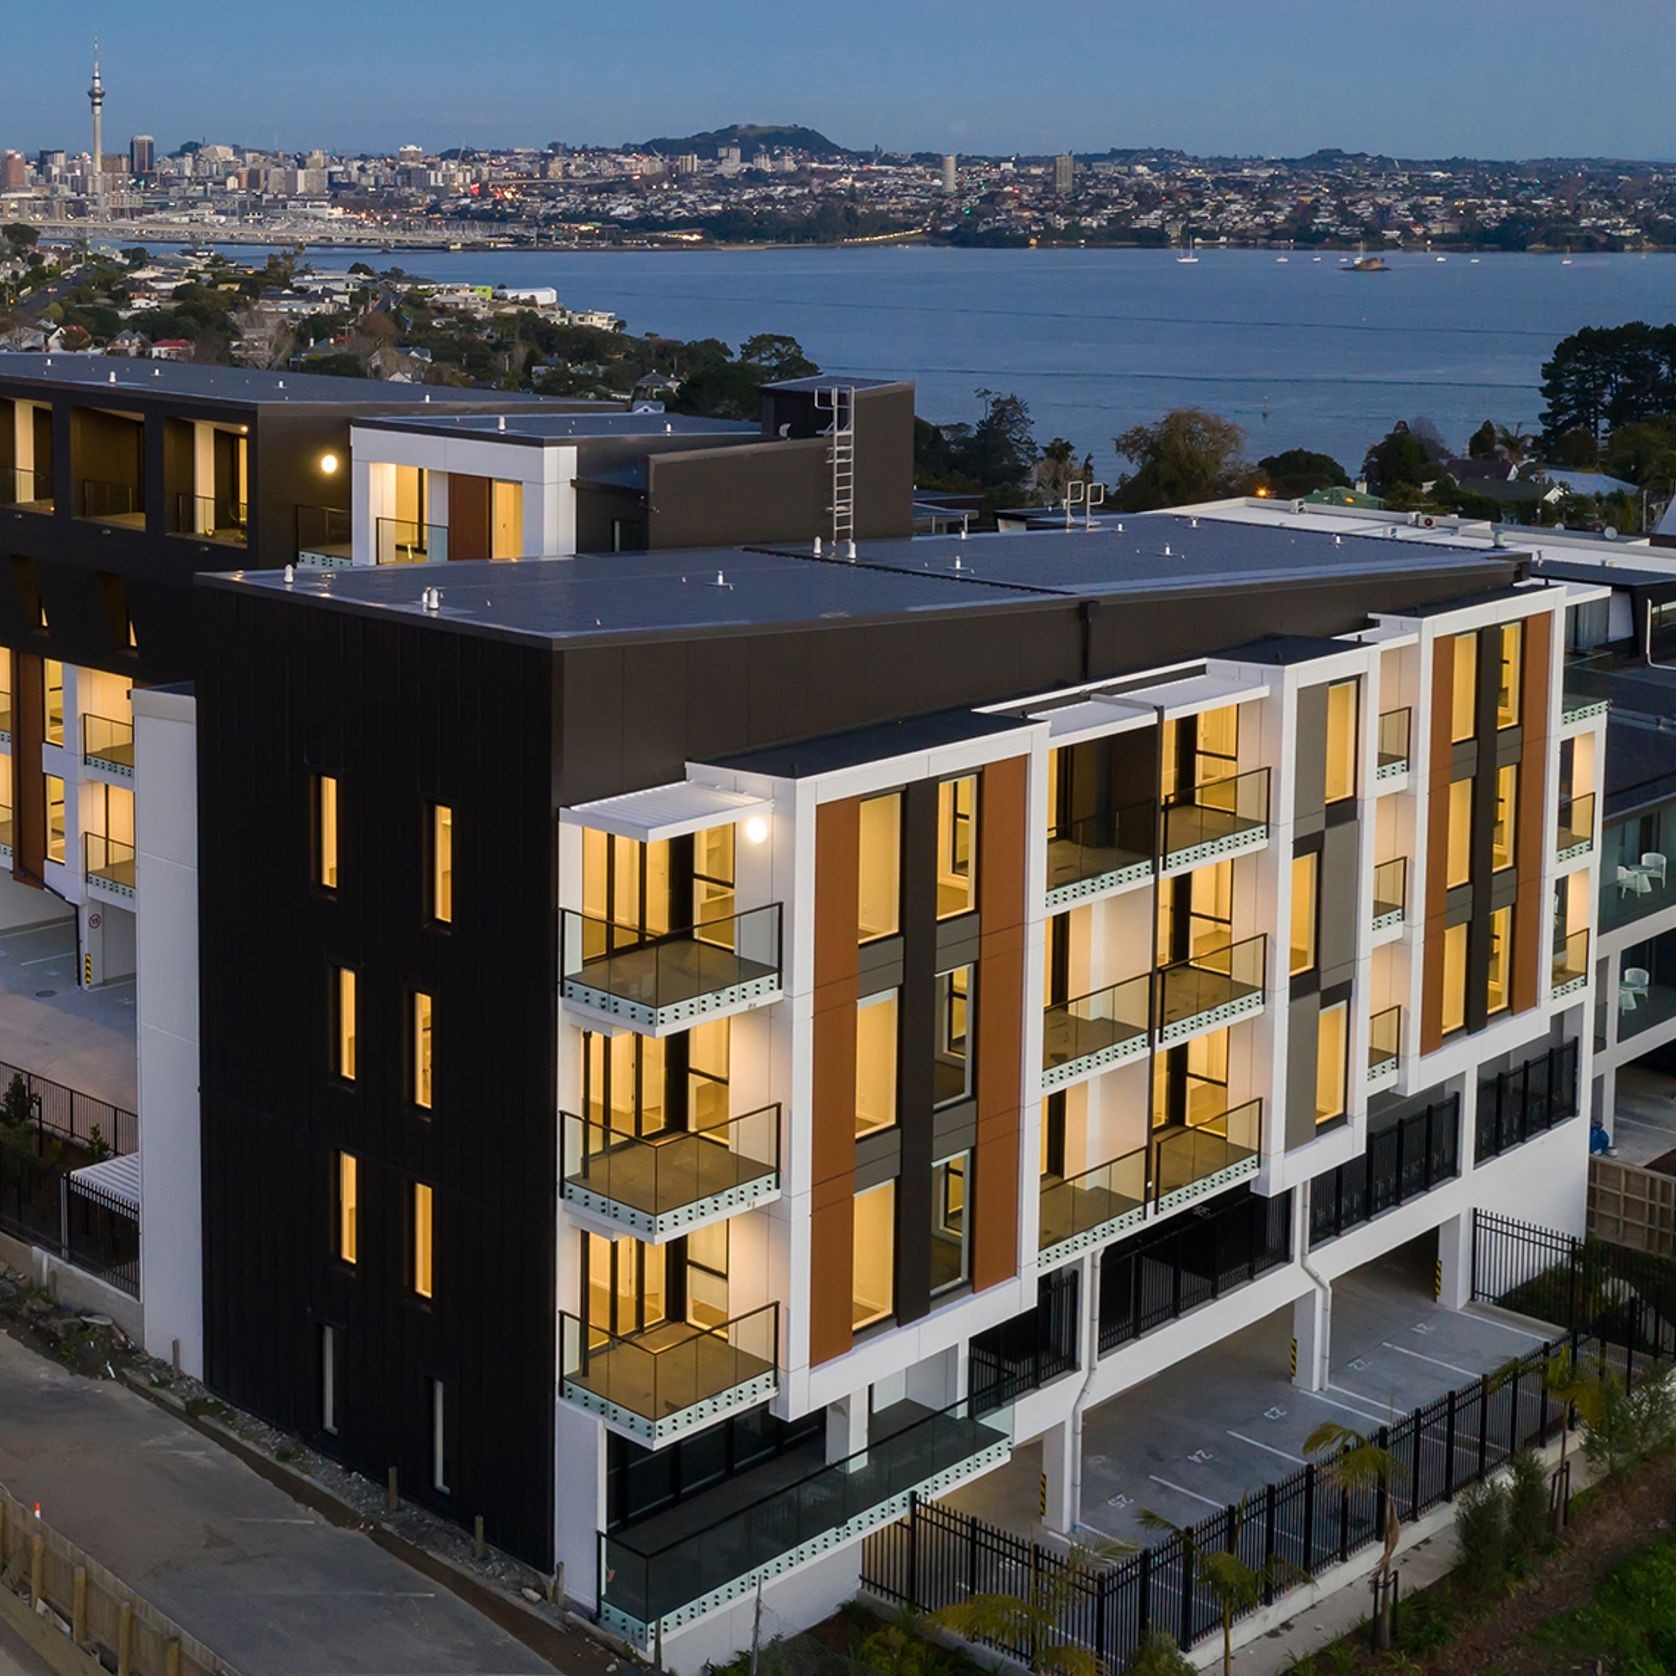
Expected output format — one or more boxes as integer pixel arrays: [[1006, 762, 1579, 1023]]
[[13, 0, 1676, 159]]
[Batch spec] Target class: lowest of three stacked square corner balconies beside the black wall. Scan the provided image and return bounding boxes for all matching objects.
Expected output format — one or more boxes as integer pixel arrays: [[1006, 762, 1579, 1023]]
[[558, 1304, 779, 1448]]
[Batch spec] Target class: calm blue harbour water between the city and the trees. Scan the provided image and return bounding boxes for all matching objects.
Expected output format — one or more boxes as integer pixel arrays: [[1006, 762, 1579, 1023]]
[[239, 246, 1676, 473]]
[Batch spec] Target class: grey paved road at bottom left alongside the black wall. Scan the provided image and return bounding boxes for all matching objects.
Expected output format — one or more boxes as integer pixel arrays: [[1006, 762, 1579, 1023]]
[[0, 1336, 551, 1676]]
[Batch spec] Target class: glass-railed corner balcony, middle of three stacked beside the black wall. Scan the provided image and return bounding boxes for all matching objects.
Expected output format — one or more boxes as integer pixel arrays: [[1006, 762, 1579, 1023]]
[[563, 1104, 779, 1244]]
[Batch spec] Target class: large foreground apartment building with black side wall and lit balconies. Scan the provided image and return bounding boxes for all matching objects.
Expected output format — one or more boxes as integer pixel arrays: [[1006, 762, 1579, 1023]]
[[127, 502, 1604, 1671]]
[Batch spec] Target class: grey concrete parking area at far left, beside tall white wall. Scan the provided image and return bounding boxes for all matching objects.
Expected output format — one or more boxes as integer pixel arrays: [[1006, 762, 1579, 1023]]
[[0, 917, 139, 1111]]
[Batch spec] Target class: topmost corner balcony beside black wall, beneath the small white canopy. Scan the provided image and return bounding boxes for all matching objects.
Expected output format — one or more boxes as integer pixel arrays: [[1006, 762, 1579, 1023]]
[[563, 902, 779, 1036]]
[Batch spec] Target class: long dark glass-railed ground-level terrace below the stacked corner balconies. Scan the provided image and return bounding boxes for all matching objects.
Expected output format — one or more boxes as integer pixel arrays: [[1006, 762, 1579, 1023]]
[[600, 1401, 1011, 1651]]
